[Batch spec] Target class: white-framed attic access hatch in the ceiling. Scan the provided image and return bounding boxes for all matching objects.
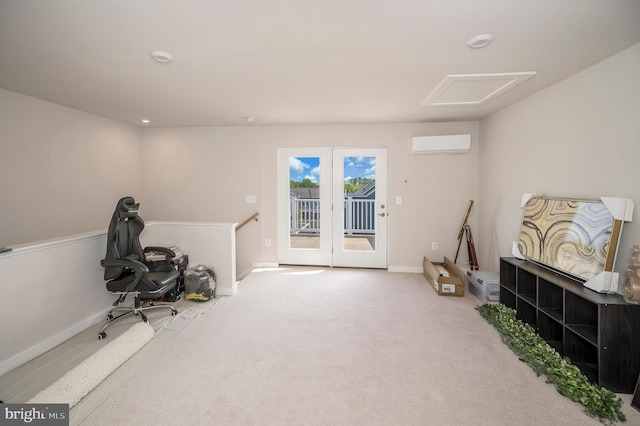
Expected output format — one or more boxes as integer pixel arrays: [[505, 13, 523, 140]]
[[420, 71, 537, 107]]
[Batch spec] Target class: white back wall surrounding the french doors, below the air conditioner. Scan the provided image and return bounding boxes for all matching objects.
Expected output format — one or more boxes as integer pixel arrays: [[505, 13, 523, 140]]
[[142, 122, 480, 272]]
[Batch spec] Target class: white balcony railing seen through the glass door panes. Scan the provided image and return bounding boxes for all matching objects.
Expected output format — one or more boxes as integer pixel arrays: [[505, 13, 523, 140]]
[[289, 198, 376, 235]]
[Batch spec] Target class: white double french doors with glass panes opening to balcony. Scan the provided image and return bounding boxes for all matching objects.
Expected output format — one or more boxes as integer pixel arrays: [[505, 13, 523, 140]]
[[278, 148, 388, 268]]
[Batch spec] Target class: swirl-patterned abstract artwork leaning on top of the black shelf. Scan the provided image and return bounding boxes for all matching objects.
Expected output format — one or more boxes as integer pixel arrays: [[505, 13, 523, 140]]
[[518, 196, 622, 281]]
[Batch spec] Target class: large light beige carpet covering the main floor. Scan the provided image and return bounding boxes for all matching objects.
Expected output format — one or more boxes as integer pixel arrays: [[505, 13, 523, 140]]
[[71, 267, 640, 426]]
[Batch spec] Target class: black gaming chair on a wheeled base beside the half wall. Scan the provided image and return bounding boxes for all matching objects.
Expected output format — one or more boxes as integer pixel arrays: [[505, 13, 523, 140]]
[[98, 197, 180, 339]]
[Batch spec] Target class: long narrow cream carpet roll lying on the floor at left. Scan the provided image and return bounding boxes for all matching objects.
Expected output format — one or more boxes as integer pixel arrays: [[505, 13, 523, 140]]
[[28, 322, 154, 408]]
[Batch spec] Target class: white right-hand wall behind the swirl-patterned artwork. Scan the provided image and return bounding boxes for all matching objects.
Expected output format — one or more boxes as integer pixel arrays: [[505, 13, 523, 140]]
[[478, 44, 640, 280]]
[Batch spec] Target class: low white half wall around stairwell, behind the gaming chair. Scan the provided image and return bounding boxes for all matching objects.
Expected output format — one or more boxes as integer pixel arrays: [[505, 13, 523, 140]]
[[0, 222, 237, 375]]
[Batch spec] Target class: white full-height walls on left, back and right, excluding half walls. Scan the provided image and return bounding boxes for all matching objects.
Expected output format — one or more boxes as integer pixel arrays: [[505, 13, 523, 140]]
[[0, 38, 640, 271]]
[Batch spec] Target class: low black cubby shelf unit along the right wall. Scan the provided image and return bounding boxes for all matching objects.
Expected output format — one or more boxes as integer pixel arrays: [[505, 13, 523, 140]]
[[500, 257, 640, 393]]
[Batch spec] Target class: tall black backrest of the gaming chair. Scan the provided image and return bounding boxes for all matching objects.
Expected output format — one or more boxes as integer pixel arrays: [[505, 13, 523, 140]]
[[104, 197, 145, 280]]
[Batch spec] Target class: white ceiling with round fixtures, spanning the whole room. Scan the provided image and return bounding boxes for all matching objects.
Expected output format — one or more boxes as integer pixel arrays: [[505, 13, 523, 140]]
[[0, 0, 640, 127]]
